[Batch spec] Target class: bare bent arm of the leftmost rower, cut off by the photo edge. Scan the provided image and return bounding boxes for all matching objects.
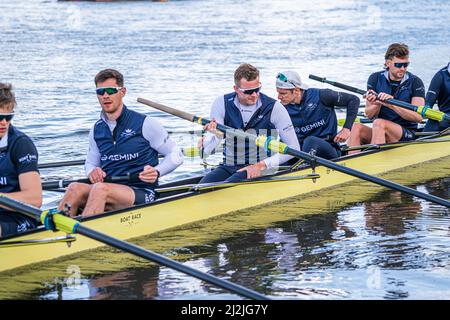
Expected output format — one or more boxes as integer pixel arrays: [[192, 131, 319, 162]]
[[0, 171, 42, 207]]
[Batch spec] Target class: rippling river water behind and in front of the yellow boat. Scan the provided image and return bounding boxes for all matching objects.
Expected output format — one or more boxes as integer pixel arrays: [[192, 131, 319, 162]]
[[0, 0, 450, 299]]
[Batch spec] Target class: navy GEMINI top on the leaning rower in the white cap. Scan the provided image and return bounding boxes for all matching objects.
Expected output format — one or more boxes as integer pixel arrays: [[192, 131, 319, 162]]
[[285, 88, 337, 145]]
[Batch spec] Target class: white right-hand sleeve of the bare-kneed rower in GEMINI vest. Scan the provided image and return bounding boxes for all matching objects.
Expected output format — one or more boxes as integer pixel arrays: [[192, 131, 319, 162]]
[[142, 117, 183, 176]]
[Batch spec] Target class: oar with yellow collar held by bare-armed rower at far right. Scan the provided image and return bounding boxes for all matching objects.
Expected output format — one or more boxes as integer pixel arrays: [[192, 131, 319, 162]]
[[309, 74, 450, 123]]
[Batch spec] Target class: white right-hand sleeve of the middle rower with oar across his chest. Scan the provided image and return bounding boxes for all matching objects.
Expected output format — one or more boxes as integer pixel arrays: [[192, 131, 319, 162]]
[[263, 101, 300, 169]]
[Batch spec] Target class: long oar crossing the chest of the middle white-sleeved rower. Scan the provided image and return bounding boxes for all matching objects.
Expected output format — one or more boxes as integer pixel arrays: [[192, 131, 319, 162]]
[[137, 98, 450, 207]]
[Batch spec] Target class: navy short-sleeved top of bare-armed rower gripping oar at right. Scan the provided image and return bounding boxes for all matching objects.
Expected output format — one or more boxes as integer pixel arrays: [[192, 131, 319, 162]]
[[367, 70, 425, 130]]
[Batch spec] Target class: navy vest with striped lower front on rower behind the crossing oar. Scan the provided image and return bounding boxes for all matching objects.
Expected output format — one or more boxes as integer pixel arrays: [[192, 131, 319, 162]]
[[223, 92, 276, 165]]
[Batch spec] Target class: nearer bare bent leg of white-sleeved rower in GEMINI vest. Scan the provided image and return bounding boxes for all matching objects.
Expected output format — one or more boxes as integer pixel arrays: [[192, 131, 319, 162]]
[[82, 182, 135, 217]]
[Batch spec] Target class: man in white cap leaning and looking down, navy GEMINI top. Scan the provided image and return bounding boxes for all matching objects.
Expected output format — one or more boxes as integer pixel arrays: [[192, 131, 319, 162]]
[[276, 71, 360, 162]]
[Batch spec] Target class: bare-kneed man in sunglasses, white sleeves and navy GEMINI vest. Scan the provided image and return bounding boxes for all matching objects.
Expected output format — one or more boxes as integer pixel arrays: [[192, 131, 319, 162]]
[[59, 69, 183, 217]]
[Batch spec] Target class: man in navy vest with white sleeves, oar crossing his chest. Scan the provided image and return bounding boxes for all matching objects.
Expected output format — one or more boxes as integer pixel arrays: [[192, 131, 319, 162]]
[[200, 63, 300, 183]]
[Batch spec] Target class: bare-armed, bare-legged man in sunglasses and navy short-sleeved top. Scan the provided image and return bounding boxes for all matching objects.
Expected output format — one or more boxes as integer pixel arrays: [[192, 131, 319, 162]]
[[347, 43, 425, 152]]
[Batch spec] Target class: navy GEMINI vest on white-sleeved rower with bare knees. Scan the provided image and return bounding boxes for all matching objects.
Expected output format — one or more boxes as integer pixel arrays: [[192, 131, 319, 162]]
[[94, 105, 158, 188]]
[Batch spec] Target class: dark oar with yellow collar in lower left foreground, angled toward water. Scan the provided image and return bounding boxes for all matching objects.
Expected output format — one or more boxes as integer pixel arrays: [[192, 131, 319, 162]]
[[0, 194, 269, 300]]
